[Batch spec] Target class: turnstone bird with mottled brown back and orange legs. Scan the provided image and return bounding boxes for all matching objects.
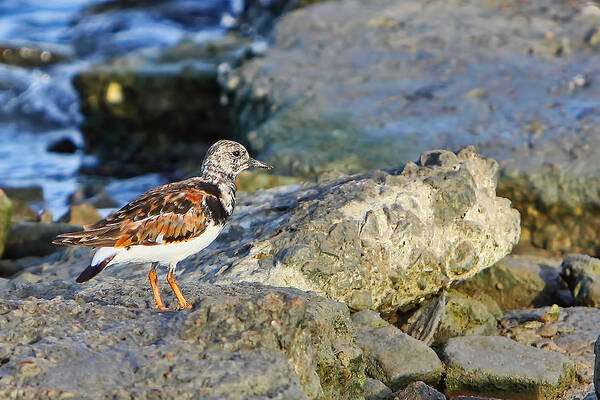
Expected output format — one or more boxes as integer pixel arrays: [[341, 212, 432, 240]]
[[53, 140, 273, 310]]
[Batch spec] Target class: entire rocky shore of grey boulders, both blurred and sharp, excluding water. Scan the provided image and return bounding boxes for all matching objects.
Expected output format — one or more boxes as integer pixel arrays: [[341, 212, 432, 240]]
[[0, 0, 600, 400]]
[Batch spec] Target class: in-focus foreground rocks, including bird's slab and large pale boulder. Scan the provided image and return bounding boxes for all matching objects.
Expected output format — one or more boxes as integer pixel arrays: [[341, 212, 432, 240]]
[[0, 148, 600, 399]]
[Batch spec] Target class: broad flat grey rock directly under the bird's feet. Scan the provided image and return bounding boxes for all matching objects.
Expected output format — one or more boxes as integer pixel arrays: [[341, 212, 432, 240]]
[[0, 282, 364, 400]]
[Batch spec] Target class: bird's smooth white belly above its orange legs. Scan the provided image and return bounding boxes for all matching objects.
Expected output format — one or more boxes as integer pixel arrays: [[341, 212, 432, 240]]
[[107, 225, 223, 265]]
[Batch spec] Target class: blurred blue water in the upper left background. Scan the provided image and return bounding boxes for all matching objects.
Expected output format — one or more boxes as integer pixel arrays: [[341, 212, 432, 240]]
[[0, 0, 242, 218]]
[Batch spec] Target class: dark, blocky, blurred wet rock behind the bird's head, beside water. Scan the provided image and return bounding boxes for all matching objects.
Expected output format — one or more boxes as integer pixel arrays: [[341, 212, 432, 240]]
[[74, 60, 229, 176]]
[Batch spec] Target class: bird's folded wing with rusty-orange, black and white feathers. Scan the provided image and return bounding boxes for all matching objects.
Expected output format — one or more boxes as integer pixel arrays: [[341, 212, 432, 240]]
[[53, 181, 227, 248]]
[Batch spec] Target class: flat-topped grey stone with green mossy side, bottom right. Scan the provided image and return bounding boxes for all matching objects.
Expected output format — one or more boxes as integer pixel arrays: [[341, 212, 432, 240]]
[[443, 336, 575, 399]]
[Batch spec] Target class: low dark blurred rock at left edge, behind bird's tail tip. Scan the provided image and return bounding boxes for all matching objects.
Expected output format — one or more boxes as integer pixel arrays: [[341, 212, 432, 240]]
[[4, 222, 81, 259]]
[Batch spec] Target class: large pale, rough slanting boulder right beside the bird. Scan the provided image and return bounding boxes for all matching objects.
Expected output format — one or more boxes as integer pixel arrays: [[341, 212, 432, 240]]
[[190, 148, 520, 311]]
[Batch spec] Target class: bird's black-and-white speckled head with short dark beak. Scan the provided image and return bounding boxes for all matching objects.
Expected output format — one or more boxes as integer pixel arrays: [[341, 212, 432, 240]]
[[202, 140, 273, 178]]
